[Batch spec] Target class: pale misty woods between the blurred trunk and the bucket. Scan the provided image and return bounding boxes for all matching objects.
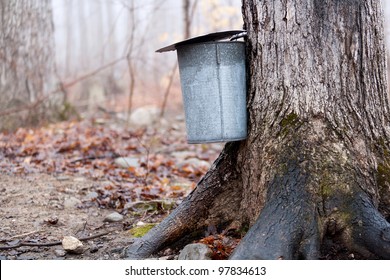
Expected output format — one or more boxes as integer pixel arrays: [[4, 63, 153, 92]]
[[53, 0, 242, 122]]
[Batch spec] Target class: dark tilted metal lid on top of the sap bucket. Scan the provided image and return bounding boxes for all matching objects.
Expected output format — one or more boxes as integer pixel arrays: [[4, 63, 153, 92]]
[[156, 30, 246, 53]]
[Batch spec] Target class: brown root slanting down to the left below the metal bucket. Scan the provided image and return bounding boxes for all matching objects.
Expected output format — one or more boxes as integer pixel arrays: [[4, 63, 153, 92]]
[[126, 144, 240, 259]]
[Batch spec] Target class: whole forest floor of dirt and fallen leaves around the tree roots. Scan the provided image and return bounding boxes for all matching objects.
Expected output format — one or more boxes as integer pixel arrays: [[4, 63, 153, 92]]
[[0, 112, 366, 260]]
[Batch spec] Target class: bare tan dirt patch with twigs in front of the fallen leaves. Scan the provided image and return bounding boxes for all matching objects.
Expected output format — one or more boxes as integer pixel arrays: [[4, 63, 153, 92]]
[[0, 174, 140, 260]]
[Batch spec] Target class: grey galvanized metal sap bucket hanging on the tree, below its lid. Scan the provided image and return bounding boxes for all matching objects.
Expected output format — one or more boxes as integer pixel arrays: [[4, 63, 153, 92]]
[[156, 30, 247, 144]]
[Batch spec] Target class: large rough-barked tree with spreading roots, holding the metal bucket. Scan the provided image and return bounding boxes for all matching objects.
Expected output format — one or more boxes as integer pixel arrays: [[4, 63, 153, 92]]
[[127, 0, 390, 259]]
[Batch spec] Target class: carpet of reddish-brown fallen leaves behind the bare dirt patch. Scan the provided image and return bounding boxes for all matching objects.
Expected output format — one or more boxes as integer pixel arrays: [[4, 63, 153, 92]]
[[0, 116, 219, 210]]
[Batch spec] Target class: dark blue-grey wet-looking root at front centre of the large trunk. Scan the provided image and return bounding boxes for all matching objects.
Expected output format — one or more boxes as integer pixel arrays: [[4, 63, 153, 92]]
[[231, 159, 320, 259]]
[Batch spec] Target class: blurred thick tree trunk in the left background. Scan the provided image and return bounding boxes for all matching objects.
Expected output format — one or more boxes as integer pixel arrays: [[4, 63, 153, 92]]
[[0, 0, 58, 130]]
